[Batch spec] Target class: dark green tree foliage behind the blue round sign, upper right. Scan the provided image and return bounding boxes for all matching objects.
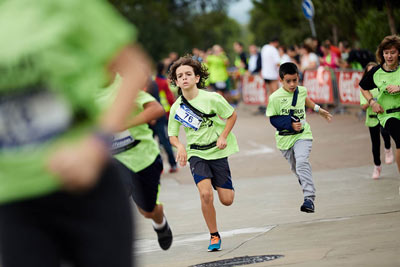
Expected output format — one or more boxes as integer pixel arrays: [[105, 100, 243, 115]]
[[249, 0, 400, 50]]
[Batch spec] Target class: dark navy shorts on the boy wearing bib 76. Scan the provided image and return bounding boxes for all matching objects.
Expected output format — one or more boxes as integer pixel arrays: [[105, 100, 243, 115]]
[[189, 156, 233, 190]]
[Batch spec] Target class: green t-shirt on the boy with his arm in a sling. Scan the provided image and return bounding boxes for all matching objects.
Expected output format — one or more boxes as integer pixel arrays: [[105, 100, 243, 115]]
[[266, 86, 313, 150]]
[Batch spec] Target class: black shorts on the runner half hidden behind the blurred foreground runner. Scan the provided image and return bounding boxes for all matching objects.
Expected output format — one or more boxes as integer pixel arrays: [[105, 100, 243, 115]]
[[116, 155, 163, 212]]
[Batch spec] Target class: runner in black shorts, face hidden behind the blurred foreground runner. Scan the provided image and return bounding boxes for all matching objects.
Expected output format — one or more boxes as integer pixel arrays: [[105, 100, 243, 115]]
[[97, 74, 173, 250]]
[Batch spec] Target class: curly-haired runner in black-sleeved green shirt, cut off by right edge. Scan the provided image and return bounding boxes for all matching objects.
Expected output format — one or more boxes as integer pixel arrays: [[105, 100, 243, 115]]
[[360, 35, 400, 173]]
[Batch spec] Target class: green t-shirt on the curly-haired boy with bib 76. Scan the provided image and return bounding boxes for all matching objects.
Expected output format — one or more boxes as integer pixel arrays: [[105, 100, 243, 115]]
[[168, 89, 239, 160]]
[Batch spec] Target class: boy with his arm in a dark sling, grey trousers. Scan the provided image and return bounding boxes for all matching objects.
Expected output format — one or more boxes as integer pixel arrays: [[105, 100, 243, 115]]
[[266, 62, 332, 213]]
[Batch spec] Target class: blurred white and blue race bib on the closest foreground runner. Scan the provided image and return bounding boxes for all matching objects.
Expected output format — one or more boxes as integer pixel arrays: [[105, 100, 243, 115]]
[[0, 90, 73, 149]]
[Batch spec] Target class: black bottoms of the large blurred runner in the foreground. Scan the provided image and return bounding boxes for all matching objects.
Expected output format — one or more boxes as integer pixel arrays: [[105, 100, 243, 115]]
[[0, 161, 133, 267]]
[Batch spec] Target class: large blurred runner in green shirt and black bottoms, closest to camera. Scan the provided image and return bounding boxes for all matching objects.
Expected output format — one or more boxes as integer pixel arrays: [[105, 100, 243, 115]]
[[0, 0, 150, 267]]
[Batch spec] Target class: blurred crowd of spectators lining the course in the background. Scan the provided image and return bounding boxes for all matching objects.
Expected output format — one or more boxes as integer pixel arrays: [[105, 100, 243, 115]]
[[149, 37, 375, 108]]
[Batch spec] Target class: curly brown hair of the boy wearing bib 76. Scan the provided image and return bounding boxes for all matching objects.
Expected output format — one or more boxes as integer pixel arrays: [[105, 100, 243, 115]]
[[168, 54, 210, 94]]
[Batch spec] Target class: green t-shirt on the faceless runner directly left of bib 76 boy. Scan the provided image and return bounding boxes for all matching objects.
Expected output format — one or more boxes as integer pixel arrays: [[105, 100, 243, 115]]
[[97, 78, 160, 172]]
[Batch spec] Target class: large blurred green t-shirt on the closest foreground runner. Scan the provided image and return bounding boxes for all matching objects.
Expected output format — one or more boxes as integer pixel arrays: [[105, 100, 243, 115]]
[[0, 0, 135, 203]]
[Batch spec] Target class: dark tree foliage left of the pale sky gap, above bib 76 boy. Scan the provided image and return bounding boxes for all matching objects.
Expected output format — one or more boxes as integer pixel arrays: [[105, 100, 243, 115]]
[[109, 0, 241, 60]]
